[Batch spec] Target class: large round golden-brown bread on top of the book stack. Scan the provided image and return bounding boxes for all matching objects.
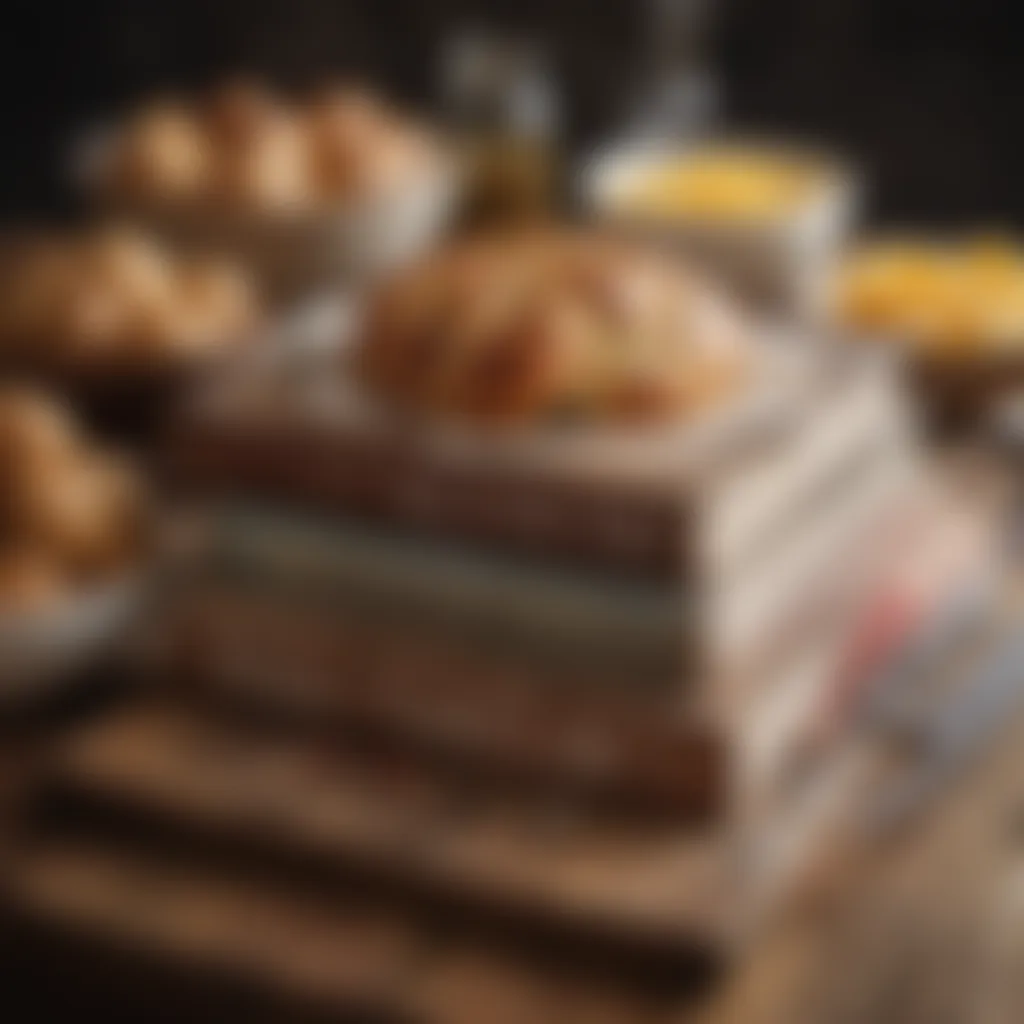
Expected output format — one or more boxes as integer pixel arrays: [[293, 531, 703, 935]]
[[355, 231, 751, 423]]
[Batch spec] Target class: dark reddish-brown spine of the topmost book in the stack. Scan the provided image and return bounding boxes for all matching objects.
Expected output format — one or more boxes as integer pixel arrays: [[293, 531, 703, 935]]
[[170, 427, 687, 579]]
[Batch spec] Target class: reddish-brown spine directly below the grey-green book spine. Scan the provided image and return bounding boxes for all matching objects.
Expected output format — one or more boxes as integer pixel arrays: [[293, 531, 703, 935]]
[[150, 591, 725, 820]]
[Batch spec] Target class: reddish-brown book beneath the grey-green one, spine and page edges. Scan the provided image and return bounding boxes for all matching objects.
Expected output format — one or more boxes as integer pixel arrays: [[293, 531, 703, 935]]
[[123, 479, 933, 821]]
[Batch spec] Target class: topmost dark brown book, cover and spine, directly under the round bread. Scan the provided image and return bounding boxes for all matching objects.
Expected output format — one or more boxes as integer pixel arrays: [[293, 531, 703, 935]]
[[161, 344, 847, 578]]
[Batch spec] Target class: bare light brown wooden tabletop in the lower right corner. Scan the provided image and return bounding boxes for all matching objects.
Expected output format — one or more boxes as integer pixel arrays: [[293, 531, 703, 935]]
[[694, 581, 1024, 1024]]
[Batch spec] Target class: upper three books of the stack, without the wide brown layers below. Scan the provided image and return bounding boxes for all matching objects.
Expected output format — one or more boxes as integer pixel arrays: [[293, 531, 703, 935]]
[[155, 333, 930, 902]]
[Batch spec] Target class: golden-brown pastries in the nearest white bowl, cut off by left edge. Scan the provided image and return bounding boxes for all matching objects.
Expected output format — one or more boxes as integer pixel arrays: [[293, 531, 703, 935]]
[[0, 385, 146, 611]]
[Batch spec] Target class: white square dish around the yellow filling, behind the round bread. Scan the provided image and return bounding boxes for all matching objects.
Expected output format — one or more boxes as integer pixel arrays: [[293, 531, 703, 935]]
[[580, 141, 859, 321]]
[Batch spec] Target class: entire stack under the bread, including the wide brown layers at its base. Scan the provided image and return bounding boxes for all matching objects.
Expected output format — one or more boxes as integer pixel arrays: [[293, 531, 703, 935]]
[[5, 323, 999, 1022]]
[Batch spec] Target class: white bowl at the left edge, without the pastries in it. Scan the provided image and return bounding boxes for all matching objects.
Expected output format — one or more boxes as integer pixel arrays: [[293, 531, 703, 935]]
[[0, 574, 146, 707]]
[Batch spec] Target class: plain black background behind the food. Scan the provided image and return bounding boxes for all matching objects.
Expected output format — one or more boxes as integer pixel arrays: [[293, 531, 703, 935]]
[[0, 0, 1024, 227]]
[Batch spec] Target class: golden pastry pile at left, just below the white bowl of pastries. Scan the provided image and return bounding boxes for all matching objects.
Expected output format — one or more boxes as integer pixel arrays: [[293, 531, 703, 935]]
[[0, 228, 258, 373]]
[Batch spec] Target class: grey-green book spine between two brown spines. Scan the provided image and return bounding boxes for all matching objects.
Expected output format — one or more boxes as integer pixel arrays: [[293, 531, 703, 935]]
[[207, 507, 696, 686]]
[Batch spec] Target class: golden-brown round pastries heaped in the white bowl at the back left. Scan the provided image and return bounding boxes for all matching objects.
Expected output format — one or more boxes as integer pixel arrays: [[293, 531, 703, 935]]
[[101, 83, 437, 213]]
